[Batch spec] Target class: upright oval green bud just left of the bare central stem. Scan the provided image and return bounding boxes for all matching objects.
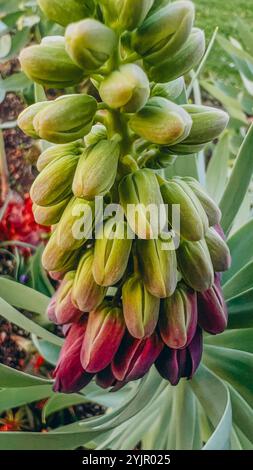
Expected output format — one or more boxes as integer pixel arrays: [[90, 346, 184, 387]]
[[72, 140, 120, 199]]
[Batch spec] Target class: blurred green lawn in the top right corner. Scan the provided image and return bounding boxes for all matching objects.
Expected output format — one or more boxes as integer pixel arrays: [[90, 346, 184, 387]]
[[194, 0, 253, 86]]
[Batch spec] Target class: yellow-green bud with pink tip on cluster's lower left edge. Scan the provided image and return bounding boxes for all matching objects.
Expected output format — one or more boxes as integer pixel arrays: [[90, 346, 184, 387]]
[[49, 271, 83, 325]]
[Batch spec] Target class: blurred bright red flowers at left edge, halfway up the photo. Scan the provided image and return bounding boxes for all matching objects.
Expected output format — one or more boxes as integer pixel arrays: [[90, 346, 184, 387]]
[[0, 194, 50, 250]]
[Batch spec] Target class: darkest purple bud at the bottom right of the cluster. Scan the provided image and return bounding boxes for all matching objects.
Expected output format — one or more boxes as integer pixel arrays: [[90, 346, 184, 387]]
[[156, 328, 203, 385]]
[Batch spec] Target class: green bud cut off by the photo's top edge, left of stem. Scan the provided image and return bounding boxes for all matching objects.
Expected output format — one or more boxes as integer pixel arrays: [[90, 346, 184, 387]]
[[38, 0, 95, 26]]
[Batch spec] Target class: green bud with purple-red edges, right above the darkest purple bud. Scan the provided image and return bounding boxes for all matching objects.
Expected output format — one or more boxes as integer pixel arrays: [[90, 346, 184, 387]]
[[159, 284, 198, 349]]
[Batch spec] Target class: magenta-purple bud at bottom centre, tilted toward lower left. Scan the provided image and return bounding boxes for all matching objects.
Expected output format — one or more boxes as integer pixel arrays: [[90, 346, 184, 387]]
[[112, 332, 163, 382]]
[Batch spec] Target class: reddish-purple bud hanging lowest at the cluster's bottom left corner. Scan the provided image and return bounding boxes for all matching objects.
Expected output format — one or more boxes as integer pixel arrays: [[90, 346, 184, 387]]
[[53, 320, 93, 393]]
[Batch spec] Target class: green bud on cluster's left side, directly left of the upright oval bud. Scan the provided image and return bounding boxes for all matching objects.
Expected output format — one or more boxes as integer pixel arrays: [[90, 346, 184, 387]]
[[30, 155, 79, 206]]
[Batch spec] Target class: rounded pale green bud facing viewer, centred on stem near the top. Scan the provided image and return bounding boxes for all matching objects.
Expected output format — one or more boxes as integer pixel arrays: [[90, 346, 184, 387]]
[[99, 64, 150, 113]]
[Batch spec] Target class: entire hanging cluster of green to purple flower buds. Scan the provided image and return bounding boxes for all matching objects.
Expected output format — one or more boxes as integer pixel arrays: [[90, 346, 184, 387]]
[[19, 0, 230, 393]]
